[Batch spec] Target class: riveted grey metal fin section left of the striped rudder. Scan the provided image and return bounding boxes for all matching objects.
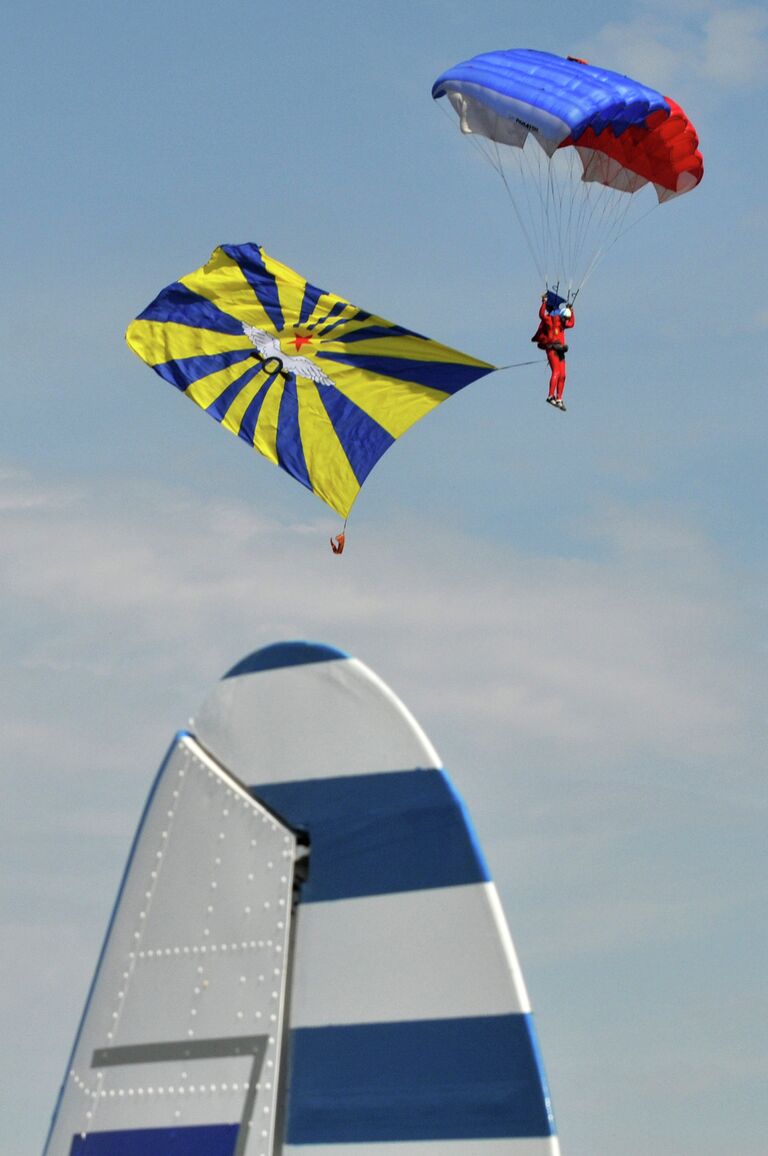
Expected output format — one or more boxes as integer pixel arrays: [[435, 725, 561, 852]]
[[45, 735, 296, 1156]]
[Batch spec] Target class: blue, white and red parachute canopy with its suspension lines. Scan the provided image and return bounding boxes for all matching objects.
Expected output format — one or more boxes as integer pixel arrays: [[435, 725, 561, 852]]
[[433, 49, 703, 292]]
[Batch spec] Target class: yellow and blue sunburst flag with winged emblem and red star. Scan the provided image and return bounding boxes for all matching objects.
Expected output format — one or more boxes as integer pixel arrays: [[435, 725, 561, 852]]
[[126, 244, 494, 518]]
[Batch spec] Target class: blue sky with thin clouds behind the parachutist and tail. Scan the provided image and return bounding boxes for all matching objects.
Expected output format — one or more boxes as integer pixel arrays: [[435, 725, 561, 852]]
[[0, 0, 768, 1156]]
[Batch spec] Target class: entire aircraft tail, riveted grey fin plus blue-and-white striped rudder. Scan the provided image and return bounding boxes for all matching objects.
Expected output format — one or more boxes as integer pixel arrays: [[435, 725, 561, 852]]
[[41, 643, 559, 1156]]
